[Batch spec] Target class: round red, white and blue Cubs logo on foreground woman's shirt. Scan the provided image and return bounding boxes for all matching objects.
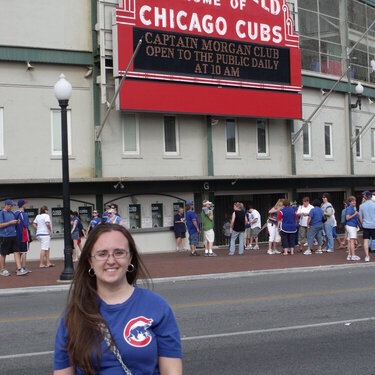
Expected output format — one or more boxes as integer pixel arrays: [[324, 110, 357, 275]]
[[124, 316, 153, 348]]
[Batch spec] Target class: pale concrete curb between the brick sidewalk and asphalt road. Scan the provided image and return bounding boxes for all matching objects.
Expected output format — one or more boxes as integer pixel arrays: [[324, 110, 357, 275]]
[[0, 262, 375, 296]]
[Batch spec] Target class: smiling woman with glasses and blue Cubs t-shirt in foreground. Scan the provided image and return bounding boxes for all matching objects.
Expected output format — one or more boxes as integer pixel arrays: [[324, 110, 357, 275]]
[[54, 224, 182, 375]]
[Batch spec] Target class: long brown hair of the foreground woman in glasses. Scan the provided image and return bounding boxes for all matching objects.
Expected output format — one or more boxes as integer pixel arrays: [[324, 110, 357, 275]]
[[65, 224, 149, 375]]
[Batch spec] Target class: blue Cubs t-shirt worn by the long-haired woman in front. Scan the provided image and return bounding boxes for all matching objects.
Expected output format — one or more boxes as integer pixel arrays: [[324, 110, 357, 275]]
[[54, 287, 182, 375]]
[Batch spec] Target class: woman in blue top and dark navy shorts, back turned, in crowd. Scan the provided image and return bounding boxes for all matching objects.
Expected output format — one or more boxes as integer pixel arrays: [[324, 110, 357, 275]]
[[278, 199, 297, 255]]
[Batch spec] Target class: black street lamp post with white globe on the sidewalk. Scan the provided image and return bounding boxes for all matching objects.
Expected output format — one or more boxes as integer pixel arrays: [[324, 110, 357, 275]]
[[54, 74, 74, 280]]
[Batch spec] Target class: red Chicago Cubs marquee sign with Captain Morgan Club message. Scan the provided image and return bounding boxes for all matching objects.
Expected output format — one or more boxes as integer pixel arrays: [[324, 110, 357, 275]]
[[114, 0, 302, 118]]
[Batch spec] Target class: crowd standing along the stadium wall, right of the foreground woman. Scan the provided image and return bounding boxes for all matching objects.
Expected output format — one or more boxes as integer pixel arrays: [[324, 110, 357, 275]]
[[174, 190, 375, 262]]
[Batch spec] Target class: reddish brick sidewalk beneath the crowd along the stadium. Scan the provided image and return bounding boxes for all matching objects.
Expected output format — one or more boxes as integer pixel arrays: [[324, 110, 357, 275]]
[[0, 245, 375, 289]]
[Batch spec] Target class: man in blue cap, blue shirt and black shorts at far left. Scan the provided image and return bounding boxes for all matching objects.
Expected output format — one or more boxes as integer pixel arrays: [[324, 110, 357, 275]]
[[0, 199, 27, 276]]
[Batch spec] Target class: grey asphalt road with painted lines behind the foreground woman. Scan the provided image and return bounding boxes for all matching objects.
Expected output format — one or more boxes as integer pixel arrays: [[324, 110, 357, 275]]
[[0, 265, 375, 375]]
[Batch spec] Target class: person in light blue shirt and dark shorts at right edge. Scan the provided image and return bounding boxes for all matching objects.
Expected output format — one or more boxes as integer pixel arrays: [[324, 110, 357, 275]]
[[359, 190, 375, 262]]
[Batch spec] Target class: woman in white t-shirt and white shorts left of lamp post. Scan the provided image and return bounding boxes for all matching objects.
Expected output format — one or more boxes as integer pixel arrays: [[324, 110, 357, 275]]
[[33, 206, 55, 268]]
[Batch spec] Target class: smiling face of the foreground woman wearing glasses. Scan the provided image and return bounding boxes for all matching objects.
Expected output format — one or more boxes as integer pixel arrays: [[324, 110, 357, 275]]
[[90, 231, 131, 288]]
